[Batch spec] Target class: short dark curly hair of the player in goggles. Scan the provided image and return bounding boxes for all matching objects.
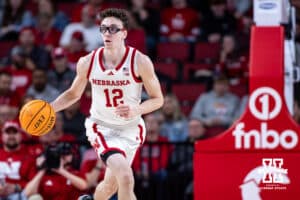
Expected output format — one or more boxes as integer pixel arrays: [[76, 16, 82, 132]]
[[100, 8, 129, 29]]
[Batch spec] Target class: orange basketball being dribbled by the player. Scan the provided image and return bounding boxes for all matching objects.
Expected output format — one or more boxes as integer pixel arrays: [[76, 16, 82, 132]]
[[19, 99, 56, 136]]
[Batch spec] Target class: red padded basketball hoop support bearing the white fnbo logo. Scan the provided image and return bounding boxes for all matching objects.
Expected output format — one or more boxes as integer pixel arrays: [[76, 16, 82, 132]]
[[194, 26, 300, 200]]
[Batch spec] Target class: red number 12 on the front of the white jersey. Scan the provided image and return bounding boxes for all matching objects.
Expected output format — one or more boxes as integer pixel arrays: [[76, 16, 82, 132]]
[[104, 88, 124, 107]]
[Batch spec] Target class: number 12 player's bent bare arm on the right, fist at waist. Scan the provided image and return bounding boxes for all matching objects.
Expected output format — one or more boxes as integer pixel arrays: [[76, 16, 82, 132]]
[[116, 52, 163, 118]]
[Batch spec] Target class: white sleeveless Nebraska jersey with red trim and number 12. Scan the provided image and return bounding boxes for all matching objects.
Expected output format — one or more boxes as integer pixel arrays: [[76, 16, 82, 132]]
[[88, 46, 142, 126]]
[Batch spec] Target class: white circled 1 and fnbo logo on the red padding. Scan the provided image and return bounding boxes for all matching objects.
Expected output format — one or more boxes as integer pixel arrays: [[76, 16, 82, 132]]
[[232, 87, 298, 149]]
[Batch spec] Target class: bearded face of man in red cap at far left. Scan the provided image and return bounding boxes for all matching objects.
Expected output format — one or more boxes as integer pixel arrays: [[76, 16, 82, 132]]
[[2, 128, 21, 149]]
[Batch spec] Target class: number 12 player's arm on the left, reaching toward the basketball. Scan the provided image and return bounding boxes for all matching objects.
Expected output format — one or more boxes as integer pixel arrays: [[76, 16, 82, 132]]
[[51, 53, 92, 112]]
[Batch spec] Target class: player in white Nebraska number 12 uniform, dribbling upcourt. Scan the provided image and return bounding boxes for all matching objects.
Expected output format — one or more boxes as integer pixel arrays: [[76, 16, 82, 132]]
[[51, 9, 163, 200]]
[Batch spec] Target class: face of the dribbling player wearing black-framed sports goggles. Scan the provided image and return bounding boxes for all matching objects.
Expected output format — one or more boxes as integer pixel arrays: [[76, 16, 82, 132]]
[[100, 17, 127, 48]]
